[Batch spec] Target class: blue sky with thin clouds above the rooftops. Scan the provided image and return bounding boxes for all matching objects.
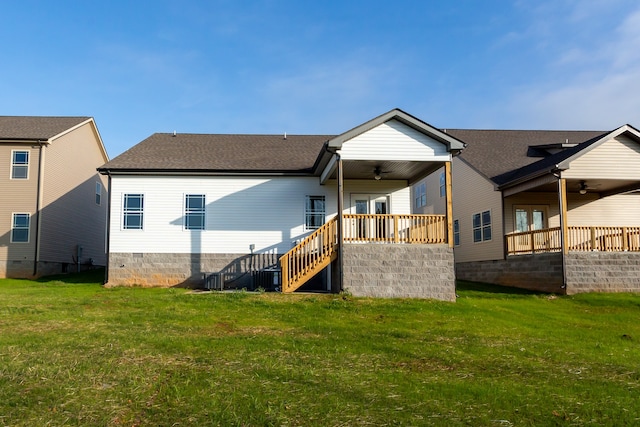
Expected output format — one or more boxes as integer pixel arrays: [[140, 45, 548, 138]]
[[0, 0, 640, 158]]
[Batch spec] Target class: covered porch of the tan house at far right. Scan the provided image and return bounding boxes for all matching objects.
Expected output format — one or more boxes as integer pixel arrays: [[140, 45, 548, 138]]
[[501, 155, 640, 294]]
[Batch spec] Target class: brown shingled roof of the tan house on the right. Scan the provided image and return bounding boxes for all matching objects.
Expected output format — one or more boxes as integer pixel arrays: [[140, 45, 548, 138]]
[[447, 129, 608, 185]]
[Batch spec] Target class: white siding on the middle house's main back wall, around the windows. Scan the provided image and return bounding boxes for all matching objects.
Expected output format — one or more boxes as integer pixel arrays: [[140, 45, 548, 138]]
[[110, 176, 411, 254]]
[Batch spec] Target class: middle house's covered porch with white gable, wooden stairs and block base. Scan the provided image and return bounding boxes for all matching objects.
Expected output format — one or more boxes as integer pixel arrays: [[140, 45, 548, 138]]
[[280, 110, 463, 300]]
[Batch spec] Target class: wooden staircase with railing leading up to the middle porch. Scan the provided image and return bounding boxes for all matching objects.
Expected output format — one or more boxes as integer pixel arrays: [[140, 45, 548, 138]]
[[280, 218, 338, 293]]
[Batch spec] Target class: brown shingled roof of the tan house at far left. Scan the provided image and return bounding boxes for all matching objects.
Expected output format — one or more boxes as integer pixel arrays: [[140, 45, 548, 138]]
[[0, 116, 90, 141]]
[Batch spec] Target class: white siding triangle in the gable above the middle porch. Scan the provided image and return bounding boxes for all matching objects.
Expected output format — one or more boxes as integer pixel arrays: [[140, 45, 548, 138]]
[[340, 120, 450, 161]]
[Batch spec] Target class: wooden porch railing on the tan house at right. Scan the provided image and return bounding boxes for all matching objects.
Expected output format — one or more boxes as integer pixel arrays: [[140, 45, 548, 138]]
[[506, 226, 640, 255]]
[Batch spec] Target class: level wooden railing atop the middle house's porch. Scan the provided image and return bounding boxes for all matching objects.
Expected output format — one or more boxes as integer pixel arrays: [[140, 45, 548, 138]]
[[343, 214, 447, 243]]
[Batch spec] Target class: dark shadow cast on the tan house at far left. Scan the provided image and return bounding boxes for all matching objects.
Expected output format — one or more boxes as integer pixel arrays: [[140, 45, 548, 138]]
[[0, 173, 108, 278]]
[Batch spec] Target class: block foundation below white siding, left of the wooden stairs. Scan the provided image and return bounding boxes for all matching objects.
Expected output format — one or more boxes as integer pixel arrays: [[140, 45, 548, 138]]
[[107, 253, 279, 288]]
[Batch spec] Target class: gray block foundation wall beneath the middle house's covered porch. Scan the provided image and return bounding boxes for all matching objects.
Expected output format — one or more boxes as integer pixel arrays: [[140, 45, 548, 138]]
[[343, 244, 456, 301]]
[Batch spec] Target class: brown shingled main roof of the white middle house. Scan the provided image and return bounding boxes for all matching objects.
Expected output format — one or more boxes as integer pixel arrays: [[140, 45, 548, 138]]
[[99, 133, 332, 173]]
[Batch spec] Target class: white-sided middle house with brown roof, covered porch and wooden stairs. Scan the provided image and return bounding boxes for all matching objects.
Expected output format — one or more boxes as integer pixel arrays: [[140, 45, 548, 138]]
[[99, 109, 463, 300]]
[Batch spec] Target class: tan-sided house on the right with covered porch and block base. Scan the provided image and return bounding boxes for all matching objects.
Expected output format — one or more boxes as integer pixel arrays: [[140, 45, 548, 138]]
[[412, 125, 640, 294]]
